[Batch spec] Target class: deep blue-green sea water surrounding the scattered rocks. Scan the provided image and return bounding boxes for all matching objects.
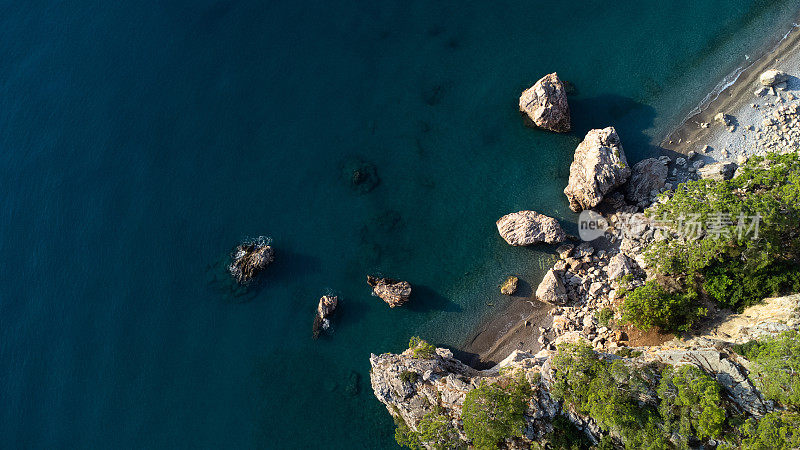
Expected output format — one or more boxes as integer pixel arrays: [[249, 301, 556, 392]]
[[0, 0, 796, 448]]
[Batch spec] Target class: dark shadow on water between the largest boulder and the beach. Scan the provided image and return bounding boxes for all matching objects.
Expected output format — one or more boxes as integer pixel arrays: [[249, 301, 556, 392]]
[[569, 94, 662, 162]]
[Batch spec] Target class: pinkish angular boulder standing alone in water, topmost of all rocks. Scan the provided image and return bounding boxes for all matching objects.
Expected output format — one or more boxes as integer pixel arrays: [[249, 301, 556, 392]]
[[519, 73, 571, 133]]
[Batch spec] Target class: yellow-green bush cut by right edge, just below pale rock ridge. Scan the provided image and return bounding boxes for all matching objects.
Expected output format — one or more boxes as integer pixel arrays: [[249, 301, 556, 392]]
[[740, 331, 800, 411]]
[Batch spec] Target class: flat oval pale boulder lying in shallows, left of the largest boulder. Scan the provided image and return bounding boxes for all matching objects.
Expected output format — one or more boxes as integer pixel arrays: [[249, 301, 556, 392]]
[[497, 211, 567, 246]]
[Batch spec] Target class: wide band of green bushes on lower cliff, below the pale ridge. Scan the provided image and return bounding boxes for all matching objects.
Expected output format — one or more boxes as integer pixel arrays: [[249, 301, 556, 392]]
[[551, 344, 726, 449]]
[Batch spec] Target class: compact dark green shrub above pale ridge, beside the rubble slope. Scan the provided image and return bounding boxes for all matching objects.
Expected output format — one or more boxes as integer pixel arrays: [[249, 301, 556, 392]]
[[622, 280, 707, 331]]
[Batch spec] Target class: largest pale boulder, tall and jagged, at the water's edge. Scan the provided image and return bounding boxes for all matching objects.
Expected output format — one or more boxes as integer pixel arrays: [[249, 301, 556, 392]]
[[564, 127, 631, 212]]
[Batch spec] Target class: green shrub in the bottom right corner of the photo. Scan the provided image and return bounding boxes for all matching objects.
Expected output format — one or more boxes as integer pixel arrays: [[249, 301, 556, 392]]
[[740, 411, 800, 450]]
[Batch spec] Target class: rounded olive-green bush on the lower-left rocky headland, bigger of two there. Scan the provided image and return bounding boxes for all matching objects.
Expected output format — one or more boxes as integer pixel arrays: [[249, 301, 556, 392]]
[[461, 376, 532, 449]]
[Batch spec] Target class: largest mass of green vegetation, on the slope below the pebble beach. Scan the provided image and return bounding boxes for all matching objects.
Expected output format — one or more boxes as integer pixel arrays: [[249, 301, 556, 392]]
[[623, 154, 800, 331]]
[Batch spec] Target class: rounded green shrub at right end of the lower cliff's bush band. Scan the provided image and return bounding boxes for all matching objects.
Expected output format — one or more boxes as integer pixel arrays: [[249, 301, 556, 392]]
[[658, 365, 725, 444]]
